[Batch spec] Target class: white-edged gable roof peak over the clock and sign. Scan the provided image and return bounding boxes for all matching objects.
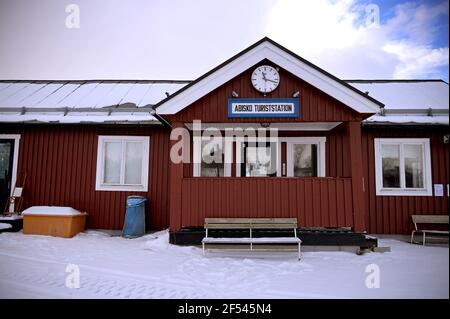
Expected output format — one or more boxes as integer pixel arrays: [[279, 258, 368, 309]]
[[156, 37, 383, 115]]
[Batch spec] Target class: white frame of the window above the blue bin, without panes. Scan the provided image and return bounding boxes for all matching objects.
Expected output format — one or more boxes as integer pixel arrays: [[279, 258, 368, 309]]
[[95, 135, 150, 192]]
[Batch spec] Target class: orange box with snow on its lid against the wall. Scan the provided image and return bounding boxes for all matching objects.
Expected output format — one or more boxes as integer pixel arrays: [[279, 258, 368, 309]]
[[22, 206, 87, 238]]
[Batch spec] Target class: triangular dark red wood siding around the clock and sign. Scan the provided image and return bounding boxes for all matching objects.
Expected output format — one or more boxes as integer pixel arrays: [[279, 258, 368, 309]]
[[168, 61, 361, 123]]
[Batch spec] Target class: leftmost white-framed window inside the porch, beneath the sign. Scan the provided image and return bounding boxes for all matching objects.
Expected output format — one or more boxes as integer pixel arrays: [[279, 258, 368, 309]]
[[194, 136, 232, 177]]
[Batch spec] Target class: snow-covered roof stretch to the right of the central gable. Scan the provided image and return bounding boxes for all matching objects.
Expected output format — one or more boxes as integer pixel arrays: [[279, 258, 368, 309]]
[[346, 80, 449, 125]]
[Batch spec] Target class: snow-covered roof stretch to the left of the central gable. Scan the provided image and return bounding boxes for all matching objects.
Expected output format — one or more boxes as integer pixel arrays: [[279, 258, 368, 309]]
[[0, 80, 189, 123]]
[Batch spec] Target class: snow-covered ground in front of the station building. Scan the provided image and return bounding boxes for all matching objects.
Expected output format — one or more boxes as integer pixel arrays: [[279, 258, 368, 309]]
[[0, 231, 449, 298]]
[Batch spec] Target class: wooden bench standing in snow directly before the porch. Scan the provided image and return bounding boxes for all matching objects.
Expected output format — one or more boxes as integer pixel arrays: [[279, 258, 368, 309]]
[[202, 218, 302, 260]]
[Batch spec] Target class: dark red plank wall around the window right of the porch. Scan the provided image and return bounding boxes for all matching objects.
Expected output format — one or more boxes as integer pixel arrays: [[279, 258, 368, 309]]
[[362, 127, 450, 234]]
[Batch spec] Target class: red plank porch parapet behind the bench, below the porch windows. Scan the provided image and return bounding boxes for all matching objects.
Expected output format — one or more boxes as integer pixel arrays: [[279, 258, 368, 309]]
[[181, 177, 353, 227]]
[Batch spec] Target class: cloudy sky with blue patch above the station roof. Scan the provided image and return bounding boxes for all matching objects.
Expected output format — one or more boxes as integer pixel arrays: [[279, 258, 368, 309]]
[[0, 0, 449, 82]]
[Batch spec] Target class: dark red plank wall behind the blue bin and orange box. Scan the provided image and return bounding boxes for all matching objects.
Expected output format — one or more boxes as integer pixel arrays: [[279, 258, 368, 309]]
[[1, 125, 169, 229]]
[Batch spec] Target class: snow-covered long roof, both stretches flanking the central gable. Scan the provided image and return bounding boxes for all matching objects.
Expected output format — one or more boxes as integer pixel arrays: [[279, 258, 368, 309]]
[[0, 80, 449, 125]]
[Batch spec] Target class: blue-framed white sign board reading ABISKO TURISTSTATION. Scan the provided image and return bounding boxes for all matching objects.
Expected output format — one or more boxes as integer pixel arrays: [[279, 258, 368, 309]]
[[228, 98, 299, 118]]
